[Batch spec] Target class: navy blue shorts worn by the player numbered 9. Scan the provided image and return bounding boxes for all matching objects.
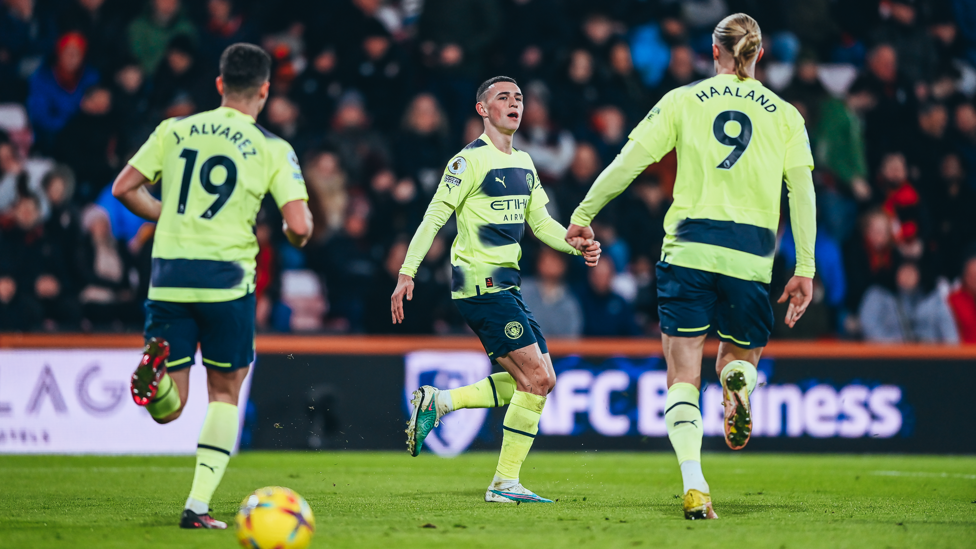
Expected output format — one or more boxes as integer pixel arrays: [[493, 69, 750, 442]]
[[657, 261, 773, 349]]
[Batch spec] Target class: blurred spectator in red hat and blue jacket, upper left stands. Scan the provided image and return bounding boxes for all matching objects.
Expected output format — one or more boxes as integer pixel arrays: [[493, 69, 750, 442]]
[[27, 32, 98, 152]]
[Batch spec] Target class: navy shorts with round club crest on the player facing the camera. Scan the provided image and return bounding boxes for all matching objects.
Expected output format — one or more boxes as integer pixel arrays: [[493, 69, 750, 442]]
[[454, 288, 549, 360]]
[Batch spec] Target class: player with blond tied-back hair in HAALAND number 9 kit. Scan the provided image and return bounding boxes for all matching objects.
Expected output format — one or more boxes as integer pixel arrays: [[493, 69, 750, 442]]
[[567, 13, 816, 520]]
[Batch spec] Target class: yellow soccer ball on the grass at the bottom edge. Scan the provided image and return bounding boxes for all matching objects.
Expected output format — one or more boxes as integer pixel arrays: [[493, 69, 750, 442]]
[[235, 486, 315, 549]]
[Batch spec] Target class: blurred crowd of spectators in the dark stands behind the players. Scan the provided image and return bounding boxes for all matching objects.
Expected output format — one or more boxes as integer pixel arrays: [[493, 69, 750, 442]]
[[0, 0, 976, 343]]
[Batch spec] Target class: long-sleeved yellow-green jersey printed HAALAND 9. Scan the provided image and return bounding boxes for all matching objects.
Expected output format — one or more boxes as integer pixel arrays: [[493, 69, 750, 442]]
[[573, 74, 816, 283]]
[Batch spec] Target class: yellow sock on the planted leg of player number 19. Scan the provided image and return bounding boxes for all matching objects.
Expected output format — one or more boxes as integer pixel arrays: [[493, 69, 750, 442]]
[[186, 402, 240, 514]]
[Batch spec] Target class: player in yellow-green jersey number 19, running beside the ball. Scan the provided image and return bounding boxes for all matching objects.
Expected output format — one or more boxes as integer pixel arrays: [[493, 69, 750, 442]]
[[112, 44, 312, 529]]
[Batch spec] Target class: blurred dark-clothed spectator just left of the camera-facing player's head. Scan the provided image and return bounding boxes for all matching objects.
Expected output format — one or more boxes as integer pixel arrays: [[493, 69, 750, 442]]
[[394, 93, 455, 197]]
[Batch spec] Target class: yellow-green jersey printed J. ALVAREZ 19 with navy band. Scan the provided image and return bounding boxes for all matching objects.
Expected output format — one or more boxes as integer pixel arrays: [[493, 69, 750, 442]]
[[129, 107, 308, 303]]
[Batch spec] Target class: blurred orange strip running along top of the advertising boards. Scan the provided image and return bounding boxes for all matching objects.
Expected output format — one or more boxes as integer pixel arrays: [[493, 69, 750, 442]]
[[0, 333, 976, 361]]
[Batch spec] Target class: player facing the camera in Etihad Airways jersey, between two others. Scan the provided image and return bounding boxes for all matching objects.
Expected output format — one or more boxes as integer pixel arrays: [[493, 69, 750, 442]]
[[391, 76, 600, 503]]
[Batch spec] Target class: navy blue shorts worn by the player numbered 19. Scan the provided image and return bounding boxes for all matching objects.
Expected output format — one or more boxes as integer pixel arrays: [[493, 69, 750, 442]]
[[145, 293, 256, 372]]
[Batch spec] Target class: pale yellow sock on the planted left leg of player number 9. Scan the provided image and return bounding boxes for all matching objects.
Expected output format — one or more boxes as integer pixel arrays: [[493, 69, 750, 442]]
[[664, 383, 708, 494]]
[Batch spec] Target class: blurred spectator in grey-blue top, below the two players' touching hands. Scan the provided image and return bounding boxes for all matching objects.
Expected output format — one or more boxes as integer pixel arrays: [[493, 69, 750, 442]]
[[522, 246, 583, 337]]
